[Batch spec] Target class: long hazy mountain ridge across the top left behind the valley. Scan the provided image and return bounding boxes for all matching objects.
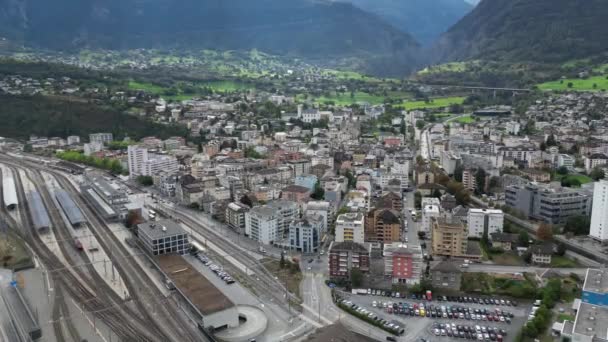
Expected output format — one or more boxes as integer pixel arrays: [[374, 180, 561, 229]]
[[0, 0, 419, 75]]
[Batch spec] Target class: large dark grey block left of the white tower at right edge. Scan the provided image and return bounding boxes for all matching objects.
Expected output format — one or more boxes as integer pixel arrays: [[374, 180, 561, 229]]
[[505, 183, 592, 224]]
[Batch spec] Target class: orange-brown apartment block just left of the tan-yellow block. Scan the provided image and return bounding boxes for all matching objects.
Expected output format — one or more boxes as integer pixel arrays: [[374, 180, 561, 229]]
[[365, 209, 402, 243]]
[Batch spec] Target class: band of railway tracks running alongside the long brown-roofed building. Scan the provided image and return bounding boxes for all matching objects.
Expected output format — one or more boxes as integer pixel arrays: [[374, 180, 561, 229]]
[[0, 157, 206, 342]]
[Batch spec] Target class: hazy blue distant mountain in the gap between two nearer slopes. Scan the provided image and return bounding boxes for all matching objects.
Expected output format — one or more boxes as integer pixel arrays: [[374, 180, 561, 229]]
[[338, 0, 473, 44]]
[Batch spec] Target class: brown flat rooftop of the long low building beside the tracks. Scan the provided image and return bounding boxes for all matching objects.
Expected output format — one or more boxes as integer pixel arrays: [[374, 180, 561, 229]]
[[157, 255, 234, 315]]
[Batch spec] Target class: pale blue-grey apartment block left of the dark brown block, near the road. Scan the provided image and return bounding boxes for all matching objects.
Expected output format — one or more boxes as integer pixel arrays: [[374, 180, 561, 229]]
[[289, 217, 323, 254]]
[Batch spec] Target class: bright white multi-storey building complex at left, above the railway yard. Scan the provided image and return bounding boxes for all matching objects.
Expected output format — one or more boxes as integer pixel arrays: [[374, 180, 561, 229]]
[[127, 145, 179, 178]]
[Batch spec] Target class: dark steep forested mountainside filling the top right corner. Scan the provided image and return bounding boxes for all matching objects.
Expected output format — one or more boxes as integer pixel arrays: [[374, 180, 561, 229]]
[[432, 0, 608, 63]]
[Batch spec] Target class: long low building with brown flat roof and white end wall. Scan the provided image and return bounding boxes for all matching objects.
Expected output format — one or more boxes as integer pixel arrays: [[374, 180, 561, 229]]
[[157, 255, 239, 330]]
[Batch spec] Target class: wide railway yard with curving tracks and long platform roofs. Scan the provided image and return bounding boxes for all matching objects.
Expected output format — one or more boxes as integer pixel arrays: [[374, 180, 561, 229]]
[[0, 154, 320, 342]]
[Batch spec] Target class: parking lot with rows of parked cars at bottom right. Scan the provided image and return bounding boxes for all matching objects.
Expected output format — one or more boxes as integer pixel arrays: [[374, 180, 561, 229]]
[[343, 293, 531, 341]]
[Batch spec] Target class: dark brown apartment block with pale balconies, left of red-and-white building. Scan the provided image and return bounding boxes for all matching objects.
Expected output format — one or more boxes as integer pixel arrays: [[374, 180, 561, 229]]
[[329, 241, 371, 279]]
